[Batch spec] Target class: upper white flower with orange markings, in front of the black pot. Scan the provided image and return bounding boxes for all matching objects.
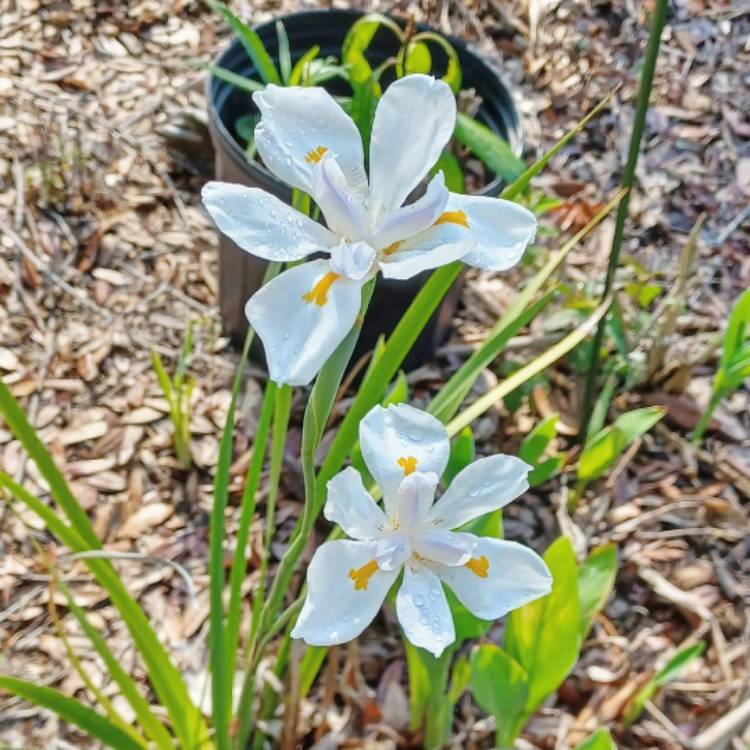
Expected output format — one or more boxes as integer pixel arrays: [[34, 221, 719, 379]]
[[203, 75, 536, 385]]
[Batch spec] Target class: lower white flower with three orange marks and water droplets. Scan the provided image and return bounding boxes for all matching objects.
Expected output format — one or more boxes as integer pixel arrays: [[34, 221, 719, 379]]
[[292, 404, 552, 656]]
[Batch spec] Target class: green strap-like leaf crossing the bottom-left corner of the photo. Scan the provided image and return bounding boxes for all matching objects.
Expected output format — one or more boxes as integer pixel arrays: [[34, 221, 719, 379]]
[[0, 676, 143, 750]]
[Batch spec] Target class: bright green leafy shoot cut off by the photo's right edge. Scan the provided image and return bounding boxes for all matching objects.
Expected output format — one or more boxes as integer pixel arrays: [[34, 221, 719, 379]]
[[693, 289, 750, 443]]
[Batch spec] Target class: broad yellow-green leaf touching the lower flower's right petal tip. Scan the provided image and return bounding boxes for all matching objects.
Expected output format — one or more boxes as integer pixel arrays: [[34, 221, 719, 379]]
[[505, 537, 581, 715]]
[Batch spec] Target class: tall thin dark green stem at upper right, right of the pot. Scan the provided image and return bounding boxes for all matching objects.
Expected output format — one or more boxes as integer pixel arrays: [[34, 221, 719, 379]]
[[581, 0, 667, 442]]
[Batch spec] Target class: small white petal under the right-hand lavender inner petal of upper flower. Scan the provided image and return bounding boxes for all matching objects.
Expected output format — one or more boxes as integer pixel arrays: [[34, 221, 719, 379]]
[[380, 224, 473, 279]]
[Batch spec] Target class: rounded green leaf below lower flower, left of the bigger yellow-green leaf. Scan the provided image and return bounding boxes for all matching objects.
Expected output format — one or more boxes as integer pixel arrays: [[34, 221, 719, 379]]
[[471, 644, 529, 748]]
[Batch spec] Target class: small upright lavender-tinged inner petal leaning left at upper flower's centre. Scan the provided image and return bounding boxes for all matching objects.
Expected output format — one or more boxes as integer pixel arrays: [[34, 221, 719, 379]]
[[310, 155, 370, 242]]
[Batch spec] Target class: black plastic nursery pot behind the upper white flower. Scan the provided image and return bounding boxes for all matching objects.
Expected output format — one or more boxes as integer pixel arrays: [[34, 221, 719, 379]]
[[207, 10, 522, 368]]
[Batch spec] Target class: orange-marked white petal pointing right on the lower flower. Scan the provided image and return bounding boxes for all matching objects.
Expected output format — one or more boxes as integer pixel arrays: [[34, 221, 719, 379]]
[[434, 534, 552, 620]]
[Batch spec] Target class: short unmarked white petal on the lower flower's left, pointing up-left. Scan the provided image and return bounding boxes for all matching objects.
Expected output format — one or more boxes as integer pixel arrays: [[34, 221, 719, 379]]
[[323, 466, 388, 539]]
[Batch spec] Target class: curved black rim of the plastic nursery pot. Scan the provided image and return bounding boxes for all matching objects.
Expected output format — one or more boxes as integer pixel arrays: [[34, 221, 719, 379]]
[[205, 8, 524, 197]]
